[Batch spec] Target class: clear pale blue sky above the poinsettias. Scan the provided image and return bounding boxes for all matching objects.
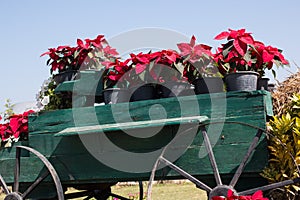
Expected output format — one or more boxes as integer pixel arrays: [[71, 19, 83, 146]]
[[0, 0, 300, 112]]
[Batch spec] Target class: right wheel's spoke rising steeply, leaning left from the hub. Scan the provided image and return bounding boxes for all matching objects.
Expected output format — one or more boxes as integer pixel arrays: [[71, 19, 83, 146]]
[[201, 127, 222, 185]]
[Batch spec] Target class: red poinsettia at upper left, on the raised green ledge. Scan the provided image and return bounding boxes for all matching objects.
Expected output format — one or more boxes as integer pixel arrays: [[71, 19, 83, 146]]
[[41, 35, 118, 74]]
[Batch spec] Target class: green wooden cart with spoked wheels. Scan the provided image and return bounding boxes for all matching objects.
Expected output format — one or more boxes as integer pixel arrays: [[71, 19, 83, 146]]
[[0, 71, 298, 200]]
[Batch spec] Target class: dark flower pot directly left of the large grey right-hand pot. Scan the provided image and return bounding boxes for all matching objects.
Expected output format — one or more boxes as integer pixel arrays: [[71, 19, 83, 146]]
[[193, 77, 224, 94]]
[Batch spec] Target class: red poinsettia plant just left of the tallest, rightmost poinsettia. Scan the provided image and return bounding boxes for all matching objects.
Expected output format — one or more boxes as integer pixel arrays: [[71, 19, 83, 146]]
[[176, 35, 220, 83]]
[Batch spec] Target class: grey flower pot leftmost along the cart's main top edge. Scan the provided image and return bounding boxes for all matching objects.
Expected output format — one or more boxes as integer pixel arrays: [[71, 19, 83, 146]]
[[103, 88, 129, 104]]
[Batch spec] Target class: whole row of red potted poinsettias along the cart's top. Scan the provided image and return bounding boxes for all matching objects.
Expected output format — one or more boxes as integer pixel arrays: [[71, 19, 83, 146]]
[[42, 29, 289, 106]]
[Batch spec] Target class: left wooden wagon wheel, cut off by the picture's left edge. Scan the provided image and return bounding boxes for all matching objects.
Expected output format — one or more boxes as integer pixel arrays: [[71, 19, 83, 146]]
[[0, 146, 64, 200]]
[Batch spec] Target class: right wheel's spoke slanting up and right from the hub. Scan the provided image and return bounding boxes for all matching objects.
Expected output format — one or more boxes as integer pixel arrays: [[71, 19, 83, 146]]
[[229, 129, 263, 187]]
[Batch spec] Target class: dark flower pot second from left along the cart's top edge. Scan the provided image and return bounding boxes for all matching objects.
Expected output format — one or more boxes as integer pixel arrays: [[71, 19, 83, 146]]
[[130, 84, 156, 101]]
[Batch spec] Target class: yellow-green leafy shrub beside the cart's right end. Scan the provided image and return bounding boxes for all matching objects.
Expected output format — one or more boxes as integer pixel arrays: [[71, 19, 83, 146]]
[[262, 94, 300, 199]]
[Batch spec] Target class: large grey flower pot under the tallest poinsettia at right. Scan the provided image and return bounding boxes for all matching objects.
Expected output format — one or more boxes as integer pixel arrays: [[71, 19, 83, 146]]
[[224, 71, 259, 91]]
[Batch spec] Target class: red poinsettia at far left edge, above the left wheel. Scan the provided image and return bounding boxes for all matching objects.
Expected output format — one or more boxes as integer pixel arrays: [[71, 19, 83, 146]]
[[0, 110, 34, 147]]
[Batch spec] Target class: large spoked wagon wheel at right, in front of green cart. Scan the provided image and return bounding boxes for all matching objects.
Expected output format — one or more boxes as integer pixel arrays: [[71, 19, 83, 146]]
[[147, 122, 300, 200]]
